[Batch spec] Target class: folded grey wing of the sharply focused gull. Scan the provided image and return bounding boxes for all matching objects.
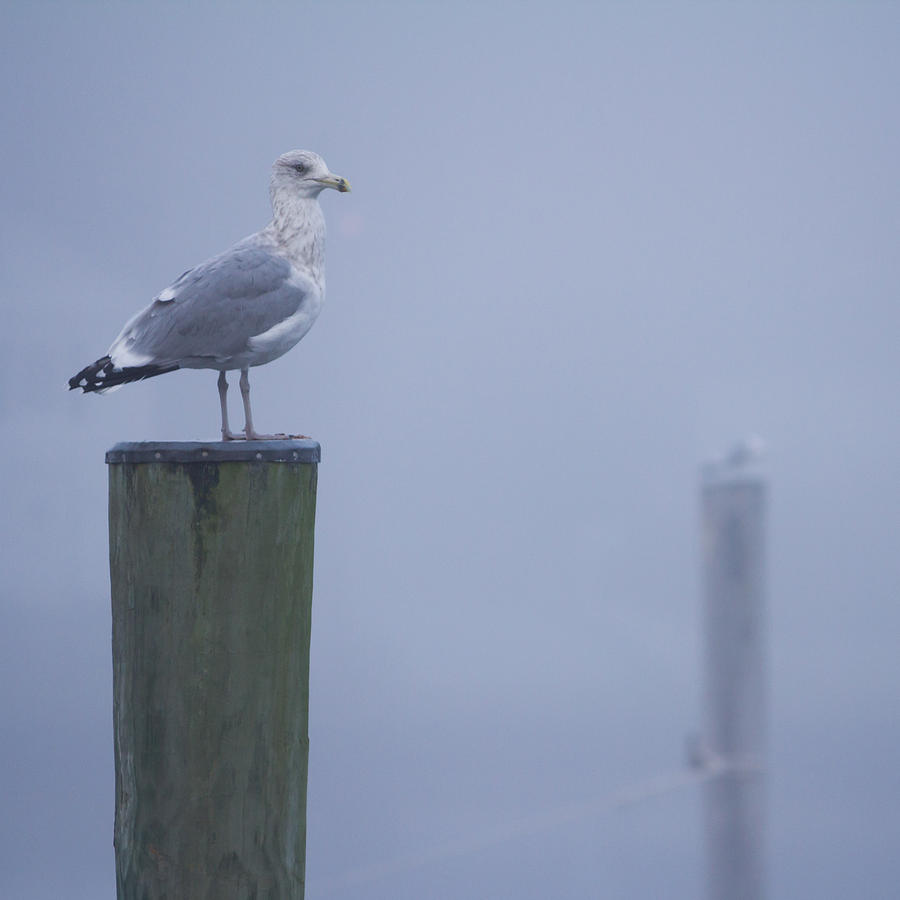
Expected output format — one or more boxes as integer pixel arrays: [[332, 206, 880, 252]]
[[109, 239, 310, 368]]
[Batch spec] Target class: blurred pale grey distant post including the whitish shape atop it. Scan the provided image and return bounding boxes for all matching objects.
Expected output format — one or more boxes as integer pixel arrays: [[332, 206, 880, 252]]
[[701, 442, 766, 900]]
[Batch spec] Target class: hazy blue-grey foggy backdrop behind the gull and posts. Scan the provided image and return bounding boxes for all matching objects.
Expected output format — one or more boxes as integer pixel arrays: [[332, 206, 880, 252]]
[[0, 2, 900, 900]]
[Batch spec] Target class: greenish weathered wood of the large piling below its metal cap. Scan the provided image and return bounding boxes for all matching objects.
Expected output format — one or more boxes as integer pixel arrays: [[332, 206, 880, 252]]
[[109, 442, 318, 900]]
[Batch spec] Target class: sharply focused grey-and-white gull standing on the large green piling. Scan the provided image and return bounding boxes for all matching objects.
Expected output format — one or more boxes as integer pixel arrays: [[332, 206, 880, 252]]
[[69, 150, 350, 441]]
